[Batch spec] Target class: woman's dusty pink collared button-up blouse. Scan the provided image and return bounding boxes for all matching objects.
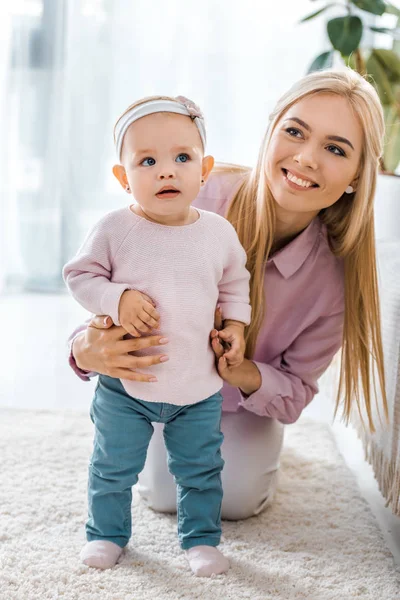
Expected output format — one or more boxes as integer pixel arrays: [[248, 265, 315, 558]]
[[70, 173, 344, 424]]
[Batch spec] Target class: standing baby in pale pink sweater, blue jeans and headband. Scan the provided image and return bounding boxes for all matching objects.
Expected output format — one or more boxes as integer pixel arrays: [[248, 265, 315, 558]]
[[63, 96, 251, 577]]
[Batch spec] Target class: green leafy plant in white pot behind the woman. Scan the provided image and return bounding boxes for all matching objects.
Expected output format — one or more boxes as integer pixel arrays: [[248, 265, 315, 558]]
[[301, 0, 400, 239]]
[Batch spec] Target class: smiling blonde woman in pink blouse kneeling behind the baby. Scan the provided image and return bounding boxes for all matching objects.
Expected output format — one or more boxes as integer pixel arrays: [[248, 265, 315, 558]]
[[70, 69, 387, 519]]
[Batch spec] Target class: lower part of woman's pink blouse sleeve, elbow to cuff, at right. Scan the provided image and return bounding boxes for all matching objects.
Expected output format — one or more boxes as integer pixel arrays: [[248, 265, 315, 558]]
[[239, 311, 344, 424]]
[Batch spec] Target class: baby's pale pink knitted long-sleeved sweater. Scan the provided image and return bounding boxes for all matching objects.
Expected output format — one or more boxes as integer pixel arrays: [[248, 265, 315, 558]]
[[63, 207, 251, 405]]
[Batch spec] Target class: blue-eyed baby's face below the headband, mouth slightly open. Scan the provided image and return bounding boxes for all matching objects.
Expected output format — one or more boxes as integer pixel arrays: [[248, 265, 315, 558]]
[[122, 113, 204, 220]]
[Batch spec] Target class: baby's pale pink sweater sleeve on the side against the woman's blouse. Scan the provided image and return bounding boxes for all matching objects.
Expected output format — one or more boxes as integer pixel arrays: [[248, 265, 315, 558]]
[[218, 221, 251, 325]]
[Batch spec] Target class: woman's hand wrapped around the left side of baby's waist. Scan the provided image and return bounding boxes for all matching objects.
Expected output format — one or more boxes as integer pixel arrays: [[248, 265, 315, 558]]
[[72, 316, 168, 382]]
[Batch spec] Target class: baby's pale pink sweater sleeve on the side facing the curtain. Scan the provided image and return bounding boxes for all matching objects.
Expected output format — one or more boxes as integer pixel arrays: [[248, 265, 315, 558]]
[[63, 218, 131, 325]]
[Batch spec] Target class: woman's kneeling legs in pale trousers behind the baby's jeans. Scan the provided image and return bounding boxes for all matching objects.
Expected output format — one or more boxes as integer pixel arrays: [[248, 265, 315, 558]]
[[138, 409, 284, 520]]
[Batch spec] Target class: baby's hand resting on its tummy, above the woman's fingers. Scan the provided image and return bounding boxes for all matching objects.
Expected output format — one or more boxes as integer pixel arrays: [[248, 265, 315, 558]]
[[118, 290, 160, 337]]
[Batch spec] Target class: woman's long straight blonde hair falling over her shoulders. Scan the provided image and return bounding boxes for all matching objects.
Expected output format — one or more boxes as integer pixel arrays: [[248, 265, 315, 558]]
[[220, 68, 388, 431]]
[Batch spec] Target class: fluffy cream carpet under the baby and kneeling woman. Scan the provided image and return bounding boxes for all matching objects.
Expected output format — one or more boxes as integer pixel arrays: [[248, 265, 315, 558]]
[[0, 410, 400, 600]]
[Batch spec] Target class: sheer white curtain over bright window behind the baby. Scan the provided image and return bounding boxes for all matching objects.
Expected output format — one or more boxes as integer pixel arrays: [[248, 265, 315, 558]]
[[0, 0, 324, 291]]
